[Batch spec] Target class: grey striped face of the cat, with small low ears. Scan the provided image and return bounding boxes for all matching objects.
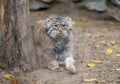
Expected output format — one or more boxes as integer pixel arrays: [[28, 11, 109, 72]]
[[45, 16, 72, 39]]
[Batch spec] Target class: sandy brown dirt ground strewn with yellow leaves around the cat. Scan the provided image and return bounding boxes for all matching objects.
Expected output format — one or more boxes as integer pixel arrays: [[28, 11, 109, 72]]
[[0, 0, 120, 84]]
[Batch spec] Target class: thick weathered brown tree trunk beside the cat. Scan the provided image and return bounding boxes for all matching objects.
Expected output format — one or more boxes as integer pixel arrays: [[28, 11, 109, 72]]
[[0, 0, 38, 70]]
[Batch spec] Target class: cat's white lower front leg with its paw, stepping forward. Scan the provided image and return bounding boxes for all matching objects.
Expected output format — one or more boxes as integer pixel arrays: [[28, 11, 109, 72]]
[[65, 57, 76, 74]]
